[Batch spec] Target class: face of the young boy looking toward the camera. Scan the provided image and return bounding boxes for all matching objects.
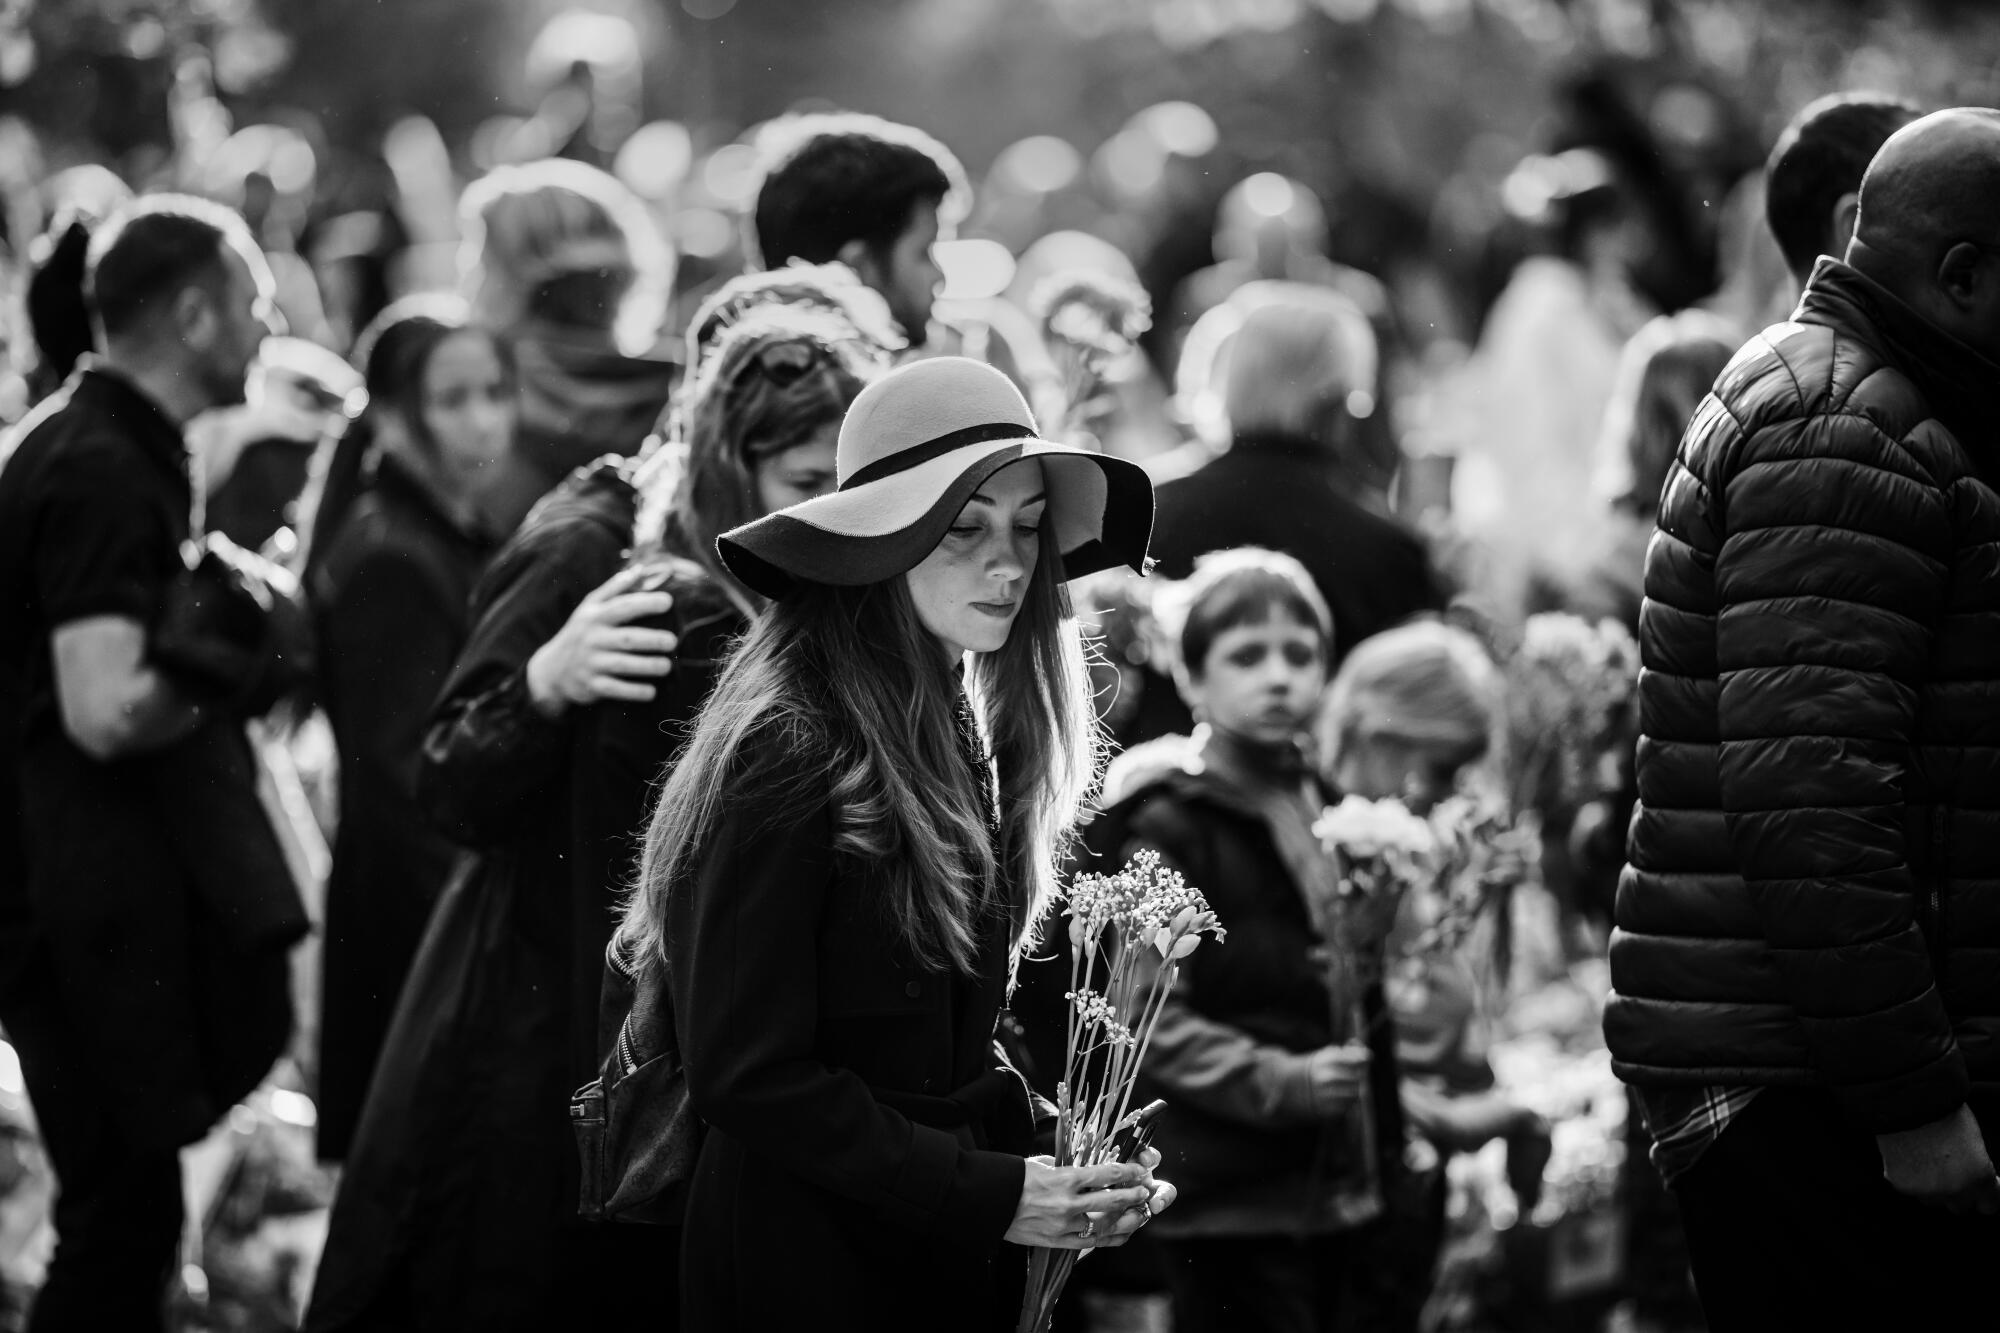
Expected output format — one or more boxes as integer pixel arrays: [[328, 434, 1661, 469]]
[[1182, 610, 1326, 745]]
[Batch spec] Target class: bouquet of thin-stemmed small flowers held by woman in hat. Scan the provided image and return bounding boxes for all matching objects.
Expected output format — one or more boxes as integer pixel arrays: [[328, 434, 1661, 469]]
[[1018, 851, 1224, 1333]]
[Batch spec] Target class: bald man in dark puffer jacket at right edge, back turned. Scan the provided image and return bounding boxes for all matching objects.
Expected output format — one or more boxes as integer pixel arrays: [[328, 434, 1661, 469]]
[[1604, 108, 2000, 1333]]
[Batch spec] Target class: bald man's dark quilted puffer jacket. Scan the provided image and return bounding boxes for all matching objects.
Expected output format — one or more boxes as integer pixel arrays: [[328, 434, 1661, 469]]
[[1604, 258, 2000, 1133]]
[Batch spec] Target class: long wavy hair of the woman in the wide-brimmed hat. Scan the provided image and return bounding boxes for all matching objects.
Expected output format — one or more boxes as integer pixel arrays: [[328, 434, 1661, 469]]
[[618, 524, 1100, 973]]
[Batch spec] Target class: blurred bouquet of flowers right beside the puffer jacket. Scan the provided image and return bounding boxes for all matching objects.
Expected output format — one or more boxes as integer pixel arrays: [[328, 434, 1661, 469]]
[[1506, 612, 1638, 815]]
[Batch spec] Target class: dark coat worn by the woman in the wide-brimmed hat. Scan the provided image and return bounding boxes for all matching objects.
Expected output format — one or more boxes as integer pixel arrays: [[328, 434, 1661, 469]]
[[668, 728, 1034, 1333]]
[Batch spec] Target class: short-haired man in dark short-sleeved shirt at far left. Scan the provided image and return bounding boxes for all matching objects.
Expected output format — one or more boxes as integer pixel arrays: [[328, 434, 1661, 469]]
[[0, 196, 296, 1331]]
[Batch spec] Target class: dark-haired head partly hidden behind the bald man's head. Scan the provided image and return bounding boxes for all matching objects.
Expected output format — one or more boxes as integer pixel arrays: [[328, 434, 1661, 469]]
[[1764, 92, 1924, 286]]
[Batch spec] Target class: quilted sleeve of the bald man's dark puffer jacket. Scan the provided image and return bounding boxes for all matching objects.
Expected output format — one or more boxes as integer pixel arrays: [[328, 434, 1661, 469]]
[[1704, 378, 1968, 1133]]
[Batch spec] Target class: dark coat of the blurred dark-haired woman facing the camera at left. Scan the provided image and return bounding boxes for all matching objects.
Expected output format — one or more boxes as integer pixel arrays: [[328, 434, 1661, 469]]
[[308, 458, 504, 1159]]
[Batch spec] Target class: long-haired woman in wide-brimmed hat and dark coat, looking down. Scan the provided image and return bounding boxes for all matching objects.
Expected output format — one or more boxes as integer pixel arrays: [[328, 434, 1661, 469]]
[[618, 358, 1172, 1331]]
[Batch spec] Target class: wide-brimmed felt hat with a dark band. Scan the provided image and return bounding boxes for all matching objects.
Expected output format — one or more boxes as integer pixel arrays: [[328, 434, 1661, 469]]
[[716, 356, 1152, 596]]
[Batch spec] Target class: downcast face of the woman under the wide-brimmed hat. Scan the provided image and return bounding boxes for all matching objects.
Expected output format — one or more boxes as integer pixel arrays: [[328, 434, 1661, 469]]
[[906, 458, 1048, 660]]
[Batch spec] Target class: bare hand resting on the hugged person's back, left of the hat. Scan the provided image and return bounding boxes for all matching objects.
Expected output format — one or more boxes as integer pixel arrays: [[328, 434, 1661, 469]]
[[528, 564, 680, 717]]
